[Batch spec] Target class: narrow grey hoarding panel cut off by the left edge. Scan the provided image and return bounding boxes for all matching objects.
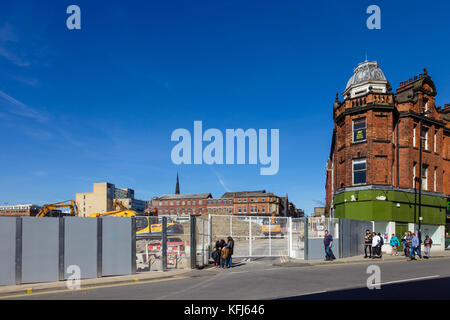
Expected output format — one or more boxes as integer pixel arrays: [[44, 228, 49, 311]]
[[0, 217, 16, 285]]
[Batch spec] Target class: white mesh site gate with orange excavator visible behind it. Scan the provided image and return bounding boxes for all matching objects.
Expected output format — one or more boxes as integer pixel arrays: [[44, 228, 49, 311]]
[[209, 215, 298, 258]]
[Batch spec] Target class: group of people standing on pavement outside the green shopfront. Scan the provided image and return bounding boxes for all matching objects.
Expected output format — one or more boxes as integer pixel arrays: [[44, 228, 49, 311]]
[[364, 230, 433, 261]]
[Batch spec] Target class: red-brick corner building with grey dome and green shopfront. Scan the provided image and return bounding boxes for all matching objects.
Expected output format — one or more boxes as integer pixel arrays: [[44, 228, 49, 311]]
[[325, 61, 450, 250]]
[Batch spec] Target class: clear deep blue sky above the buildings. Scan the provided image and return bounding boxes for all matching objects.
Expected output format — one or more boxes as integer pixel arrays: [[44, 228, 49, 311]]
[[0, 0, 450, 213]]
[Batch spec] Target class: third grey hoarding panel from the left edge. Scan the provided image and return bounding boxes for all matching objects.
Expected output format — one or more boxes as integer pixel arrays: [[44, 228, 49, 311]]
[[64, 217, 97, 279]]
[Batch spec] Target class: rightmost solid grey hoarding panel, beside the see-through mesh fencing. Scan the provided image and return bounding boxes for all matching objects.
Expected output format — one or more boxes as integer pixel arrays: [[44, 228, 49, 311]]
[[102, 217, 132, 276]]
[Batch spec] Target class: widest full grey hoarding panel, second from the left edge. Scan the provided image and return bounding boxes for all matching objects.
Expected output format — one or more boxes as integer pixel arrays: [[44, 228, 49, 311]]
[[22, 217, 59, 283]]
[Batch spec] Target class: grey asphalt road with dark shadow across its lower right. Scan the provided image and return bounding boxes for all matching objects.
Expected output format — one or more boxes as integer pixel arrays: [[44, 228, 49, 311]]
[[6, 258, 450, 300]]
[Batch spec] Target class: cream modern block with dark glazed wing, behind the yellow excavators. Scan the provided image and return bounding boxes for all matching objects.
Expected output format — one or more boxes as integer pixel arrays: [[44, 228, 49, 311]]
[[75, 182, 148, 217]]
